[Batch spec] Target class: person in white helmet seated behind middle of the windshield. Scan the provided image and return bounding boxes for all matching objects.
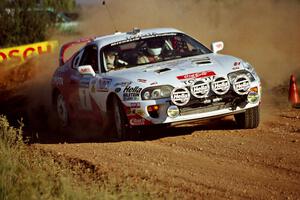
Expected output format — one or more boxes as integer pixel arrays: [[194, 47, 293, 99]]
[[137, 38, 164, 64]]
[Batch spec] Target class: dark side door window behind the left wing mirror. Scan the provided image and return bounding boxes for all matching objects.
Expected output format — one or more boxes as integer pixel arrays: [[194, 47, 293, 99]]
[[79, 45, 99, 73]]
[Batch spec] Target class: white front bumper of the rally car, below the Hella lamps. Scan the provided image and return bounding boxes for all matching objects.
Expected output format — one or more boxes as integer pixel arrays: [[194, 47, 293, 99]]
[[125, 90, 261, 126]]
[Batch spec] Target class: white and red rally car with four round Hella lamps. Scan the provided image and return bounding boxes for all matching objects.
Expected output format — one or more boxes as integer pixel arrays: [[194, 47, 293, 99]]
[[52, 28, 261, 138]]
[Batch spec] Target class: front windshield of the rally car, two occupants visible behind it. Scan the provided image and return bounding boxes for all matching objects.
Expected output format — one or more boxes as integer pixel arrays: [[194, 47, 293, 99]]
[[101, 33, 211, 71]]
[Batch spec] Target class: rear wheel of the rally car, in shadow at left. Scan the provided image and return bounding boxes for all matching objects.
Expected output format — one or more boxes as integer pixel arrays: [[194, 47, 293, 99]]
[[55, 93, 70, 128]]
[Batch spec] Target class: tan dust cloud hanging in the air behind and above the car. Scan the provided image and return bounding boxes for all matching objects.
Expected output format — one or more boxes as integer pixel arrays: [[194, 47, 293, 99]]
[[81, 0, 300, 88]]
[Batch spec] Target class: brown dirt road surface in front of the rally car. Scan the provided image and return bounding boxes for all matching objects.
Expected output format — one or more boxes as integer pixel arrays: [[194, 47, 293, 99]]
[[34, 109, 300, 199]]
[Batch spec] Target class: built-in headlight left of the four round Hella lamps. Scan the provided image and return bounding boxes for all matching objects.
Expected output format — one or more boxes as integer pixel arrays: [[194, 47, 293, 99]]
[[142, 85, 173, 100]]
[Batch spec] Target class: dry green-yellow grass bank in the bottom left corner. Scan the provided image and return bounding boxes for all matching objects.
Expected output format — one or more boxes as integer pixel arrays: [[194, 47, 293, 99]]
[[0, 116, 150, 199]]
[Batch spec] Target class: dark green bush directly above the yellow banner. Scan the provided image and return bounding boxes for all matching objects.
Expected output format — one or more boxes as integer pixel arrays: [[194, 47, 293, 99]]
[[0, 0, 50, 47]]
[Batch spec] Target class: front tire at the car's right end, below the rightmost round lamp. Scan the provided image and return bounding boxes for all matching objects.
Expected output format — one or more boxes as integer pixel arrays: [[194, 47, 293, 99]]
[[234, 106, 260, 129]]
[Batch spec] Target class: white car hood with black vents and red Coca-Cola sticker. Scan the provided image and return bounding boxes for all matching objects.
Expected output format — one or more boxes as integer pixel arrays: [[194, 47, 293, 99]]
[[107, 53, 244, 87]]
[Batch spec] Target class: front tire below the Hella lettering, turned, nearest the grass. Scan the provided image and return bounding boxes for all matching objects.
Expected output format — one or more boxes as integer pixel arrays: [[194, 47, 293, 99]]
[[111, 97, 134, 140]]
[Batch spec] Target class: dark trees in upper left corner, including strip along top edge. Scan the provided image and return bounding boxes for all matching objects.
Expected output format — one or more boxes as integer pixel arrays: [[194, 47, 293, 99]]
[[0, 0, 76, 48]]
